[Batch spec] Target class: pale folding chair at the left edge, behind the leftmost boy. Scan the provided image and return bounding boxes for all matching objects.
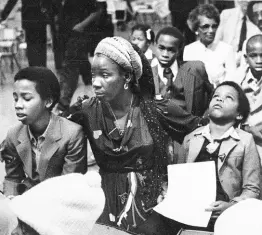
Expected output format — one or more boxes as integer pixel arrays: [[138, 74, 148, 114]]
[[0, 28, 21, 84]]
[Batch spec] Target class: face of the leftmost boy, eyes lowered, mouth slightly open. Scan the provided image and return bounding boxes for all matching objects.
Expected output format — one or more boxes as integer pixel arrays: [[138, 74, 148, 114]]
[[13, 79, 49, 125]]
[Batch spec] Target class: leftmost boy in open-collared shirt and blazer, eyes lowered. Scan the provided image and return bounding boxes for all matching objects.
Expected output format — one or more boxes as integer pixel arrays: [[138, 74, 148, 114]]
[[0, 67, 87, 195]]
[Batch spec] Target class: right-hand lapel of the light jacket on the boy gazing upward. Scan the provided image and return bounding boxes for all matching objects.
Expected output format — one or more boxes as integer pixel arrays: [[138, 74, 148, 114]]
[[217, 135, 240, 172]]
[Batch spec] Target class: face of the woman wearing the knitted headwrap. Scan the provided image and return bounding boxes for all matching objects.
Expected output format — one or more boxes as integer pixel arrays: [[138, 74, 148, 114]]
[[92, 54, 125, 102]]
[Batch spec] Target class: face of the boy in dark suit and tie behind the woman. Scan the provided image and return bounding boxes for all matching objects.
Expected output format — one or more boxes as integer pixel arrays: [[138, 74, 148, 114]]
[[156, 34, 180, 67]]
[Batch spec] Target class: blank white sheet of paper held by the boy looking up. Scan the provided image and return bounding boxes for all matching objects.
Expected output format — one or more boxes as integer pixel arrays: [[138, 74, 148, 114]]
[[154, 161, 216, 227]]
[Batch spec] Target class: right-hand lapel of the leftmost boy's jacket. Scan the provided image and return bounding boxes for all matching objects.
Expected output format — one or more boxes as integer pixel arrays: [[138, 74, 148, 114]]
[[38, 115, 62, 181]]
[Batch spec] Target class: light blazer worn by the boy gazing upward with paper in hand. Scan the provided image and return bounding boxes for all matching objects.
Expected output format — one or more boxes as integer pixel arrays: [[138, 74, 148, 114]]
[[177, 127, 261, 201]]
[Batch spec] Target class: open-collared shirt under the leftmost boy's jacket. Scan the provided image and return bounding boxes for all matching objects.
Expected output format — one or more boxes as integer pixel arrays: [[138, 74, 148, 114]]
[[28, 113, 54, 171]]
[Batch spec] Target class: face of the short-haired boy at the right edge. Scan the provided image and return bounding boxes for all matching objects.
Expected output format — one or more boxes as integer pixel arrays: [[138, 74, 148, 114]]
[[246, 40, 262, 75]]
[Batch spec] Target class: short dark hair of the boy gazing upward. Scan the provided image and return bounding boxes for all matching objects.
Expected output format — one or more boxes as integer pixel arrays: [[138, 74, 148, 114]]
[[214, 81, 250, 126]]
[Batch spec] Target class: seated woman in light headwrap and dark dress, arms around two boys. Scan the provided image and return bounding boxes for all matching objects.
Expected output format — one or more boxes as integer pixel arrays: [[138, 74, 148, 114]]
[[67, 37, 203, 234]]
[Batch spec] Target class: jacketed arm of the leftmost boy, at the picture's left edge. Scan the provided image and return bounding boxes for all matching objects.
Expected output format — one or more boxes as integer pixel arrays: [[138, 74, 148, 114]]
[[0, 134, 26, 196]]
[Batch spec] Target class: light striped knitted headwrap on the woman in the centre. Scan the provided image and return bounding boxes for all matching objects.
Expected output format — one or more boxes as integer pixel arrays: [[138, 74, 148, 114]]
[[95, 37, 143, 81]]
